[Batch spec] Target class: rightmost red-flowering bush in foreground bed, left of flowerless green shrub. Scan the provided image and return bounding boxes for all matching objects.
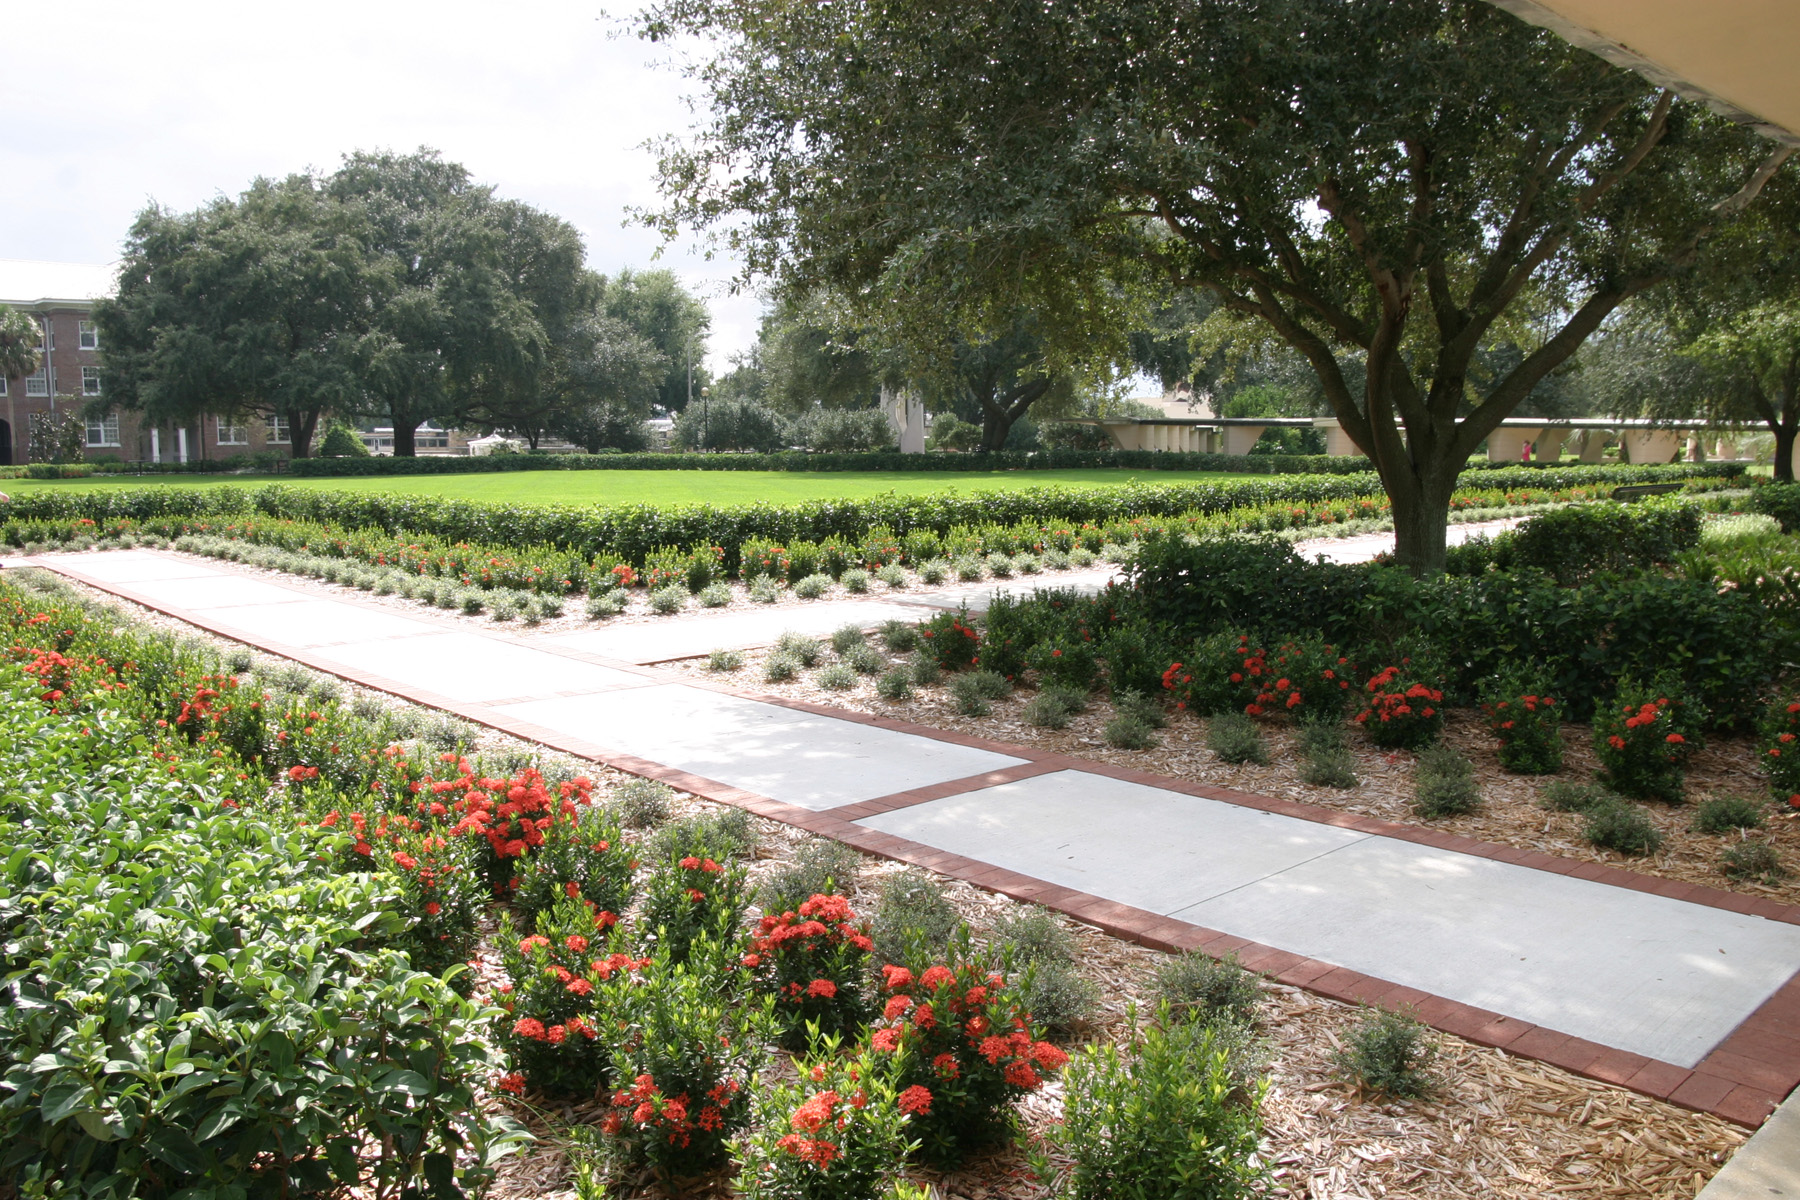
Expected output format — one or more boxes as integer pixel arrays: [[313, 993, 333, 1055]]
[[869, 961, 1069, 1162]]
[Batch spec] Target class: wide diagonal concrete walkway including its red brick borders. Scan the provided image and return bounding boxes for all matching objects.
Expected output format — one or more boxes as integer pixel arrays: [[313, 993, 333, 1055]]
[[14, 551, 1800, 1124]]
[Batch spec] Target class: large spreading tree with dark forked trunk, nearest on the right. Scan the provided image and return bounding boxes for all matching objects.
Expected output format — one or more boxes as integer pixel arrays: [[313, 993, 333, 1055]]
[[643, 0, 1791, 570]]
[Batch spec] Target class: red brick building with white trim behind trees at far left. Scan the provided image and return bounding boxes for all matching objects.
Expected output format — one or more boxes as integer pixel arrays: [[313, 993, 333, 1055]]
[[0, 259, 292, 466]]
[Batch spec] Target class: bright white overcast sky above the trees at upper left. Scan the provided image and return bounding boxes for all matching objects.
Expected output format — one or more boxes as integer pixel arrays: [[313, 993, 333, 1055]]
[[0, 0, 761, 369]]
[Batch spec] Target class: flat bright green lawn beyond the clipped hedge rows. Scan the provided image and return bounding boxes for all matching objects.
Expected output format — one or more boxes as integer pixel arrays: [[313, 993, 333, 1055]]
[[0, 468, 1244, 504]]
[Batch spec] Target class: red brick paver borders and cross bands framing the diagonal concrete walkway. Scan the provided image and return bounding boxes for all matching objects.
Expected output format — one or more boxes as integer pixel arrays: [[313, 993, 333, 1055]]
[[17, 556, 1800, 1128]]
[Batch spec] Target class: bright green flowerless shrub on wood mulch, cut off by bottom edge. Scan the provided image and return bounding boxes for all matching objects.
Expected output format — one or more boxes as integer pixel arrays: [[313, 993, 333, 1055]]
[[1037, 1015, 1265, 1200]]
